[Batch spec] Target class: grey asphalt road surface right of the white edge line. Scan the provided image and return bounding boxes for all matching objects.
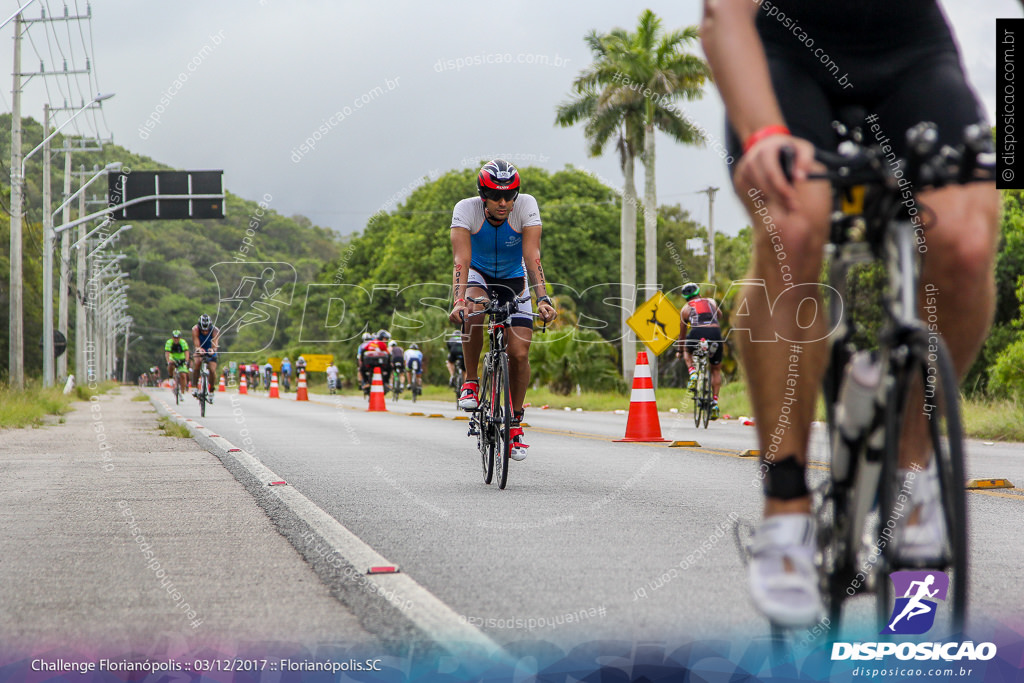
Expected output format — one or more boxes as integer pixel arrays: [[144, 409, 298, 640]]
[[154, 391, 1024, 647]]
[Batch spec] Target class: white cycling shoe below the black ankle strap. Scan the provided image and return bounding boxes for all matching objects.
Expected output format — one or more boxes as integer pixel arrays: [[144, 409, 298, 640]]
[[749, 514, 823, 628]]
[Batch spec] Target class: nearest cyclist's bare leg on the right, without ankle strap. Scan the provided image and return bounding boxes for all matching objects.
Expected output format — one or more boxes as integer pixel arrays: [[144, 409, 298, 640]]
[[900, 183, 999, 516]]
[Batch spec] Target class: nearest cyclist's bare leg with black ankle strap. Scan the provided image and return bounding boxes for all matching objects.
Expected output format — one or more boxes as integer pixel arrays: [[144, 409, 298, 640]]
[[733, 182, 831, 517]]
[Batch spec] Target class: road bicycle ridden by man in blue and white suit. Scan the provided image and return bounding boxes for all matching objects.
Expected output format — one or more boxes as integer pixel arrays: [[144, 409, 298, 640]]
[[459, 292, 539, 488]]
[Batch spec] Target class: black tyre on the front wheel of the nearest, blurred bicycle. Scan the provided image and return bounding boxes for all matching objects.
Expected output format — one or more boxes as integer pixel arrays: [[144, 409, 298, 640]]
[[877, 331, 970, 634]]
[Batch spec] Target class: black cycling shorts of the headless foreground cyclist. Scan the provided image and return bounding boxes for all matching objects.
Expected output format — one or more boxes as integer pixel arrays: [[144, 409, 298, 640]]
[[726, 23, 988, 171]]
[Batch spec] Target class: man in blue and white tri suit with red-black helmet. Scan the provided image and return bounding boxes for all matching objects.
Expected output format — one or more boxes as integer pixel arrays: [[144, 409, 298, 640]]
[[449, 159, 557, 460]]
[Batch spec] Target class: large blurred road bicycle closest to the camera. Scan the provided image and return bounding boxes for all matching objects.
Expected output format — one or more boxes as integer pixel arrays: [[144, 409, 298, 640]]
[[749, 116, 995, 637]]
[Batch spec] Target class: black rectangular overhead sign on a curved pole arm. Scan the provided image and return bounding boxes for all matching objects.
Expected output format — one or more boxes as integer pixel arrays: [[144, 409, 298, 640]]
[[108, 171, 224, 220]]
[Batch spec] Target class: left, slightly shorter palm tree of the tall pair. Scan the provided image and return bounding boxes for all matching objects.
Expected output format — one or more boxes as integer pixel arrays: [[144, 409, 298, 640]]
[[555, 29, 643, 381]]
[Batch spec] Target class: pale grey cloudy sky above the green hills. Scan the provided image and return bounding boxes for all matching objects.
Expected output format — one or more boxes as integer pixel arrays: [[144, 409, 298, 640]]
[[0, 0, 1021, 245]]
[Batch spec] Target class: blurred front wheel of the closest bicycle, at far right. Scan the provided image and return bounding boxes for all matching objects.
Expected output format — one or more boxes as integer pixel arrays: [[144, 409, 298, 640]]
[[878, 331, 970, 635]]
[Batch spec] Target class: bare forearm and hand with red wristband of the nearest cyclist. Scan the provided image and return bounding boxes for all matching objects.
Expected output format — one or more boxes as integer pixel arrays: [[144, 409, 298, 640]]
[[700, 0, 814, 204]]
